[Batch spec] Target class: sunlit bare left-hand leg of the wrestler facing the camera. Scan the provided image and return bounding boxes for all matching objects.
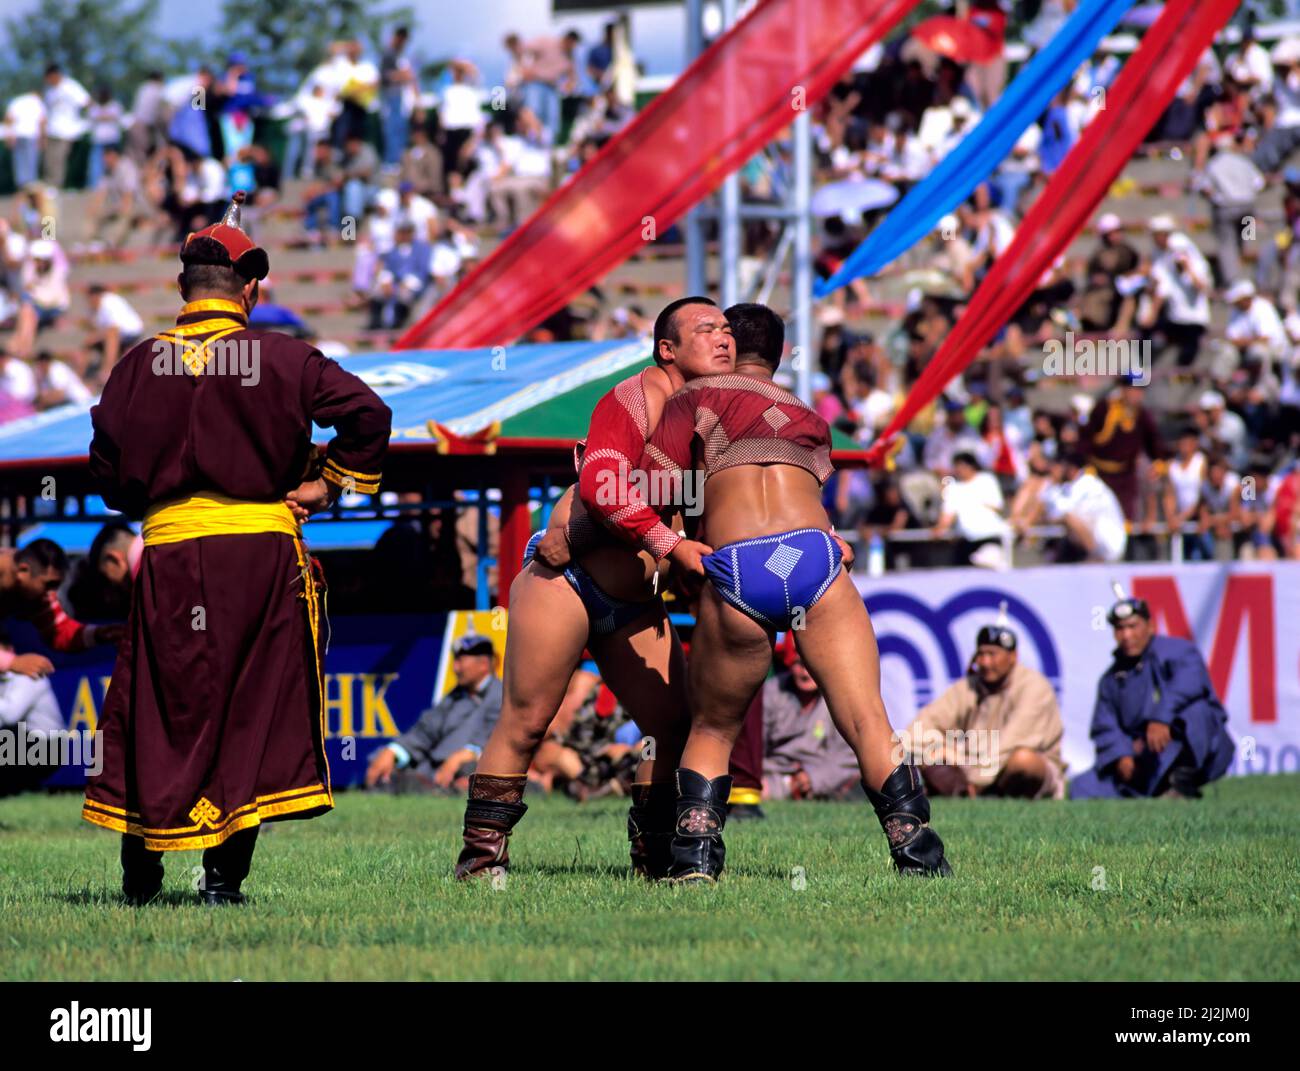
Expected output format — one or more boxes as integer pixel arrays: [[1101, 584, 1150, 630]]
[[478, 561, 588, 776]]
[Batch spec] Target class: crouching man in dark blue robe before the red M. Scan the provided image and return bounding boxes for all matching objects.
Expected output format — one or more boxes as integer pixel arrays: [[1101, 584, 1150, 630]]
[[1070, 590, 1235, 799]]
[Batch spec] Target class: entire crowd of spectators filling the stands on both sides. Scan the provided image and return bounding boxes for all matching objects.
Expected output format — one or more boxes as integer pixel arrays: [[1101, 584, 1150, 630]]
[[0, 10, 1300, 568]]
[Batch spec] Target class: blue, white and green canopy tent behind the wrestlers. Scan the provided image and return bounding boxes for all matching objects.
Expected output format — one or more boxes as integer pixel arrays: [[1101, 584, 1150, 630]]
[[0, 339, 863, 590]]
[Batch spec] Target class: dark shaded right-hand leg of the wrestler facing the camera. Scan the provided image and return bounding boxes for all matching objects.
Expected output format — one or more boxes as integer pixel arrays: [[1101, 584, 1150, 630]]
[[589, 602, 690, 781]]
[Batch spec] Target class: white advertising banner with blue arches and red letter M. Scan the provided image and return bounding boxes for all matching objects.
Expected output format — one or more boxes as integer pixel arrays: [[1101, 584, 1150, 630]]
[[857, 561, 1300, 776]]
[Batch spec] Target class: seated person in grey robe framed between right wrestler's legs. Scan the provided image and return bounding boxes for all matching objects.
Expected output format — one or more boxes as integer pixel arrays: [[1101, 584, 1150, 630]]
[[762, 632, 862, 799]]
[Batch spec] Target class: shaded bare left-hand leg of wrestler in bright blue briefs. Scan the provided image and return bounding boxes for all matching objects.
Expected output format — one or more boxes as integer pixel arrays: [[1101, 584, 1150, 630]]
[[681, 584, 774, 780]]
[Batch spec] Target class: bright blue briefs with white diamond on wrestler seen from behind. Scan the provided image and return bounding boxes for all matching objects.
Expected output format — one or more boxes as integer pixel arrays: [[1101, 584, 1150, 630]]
[[703, 528, 842, 632]]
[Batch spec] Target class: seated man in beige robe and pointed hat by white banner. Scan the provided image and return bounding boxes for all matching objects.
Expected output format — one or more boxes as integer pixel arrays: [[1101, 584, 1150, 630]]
[[900, 623, 1065, 799]]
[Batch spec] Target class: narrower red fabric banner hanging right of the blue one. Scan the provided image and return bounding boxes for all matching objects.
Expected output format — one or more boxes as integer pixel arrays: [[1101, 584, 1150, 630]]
[[867, 0, 1239, 463]]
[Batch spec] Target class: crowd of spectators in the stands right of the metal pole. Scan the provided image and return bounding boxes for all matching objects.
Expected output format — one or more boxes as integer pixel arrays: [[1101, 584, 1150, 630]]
[[800, 16, 1300, 568]]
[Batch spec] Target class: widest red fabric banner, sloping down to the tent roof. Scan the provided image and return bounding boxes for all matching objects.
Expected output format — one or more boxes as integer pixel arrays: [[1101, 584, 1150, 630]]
[[395, 0, 918, 350]]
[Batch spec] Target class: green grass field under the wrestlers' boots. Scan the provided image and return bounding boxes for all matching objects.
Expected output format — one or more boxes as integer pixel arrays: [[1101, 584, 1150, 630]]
[[0, 776, 1300, 980]]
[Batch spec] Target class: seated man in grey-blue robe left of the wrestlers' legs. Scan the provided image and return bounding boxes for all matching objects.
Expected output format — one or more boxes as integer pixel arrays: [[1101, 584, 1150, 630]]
[[365, 634, 502, 793]]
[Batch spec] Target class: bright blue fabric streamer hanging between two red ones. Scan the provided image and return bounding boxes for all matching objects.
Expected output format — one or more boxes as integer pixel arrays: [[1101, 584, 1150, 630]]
[[813, 0, 1132, 298]]
